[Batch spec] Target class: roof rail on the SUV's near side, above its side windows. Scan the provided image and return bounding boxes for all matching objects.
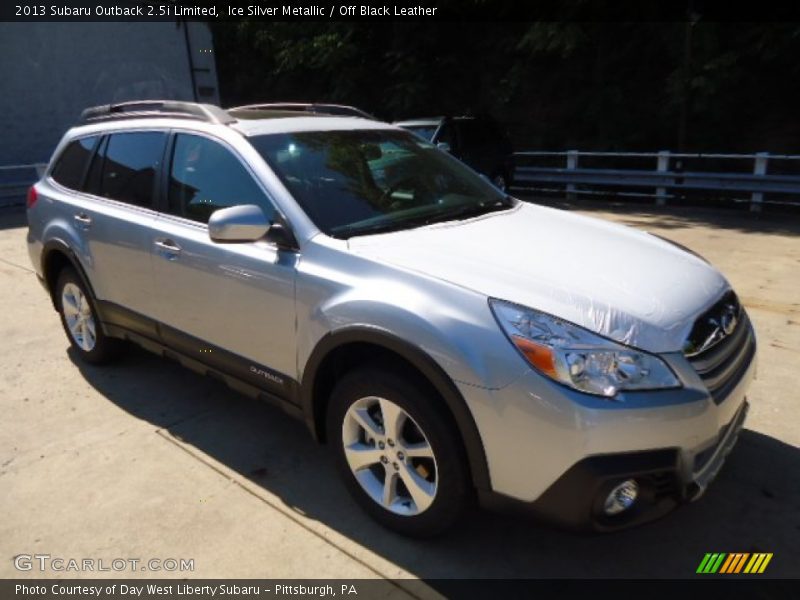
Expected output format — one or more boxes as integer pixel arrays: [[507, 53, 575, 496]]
[[80, 100, 236, 125]]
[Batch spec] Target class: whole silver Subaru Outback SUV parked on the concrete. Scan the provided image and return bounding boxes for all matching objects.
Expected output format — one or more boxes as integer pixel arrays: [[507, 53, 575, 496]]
[[28, 102, 756, 536]]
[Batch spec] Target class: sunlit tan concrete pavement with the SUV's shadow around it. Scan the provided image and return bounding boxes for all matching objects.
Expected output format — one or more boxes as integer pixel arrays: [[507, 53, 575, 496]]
[[0, 205, 800, 584]]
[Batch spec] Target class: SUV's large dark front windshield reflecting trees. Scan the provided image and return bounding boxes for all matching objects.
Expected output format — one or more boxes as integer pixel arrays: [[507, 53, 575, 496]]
[[250, 130, 514, 238]]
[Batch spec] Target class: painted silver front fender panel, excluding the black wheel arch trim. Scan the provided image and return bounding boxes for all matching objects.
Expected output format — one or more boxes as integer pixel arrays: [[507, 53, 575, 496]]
[[298, 259, 527, 389]]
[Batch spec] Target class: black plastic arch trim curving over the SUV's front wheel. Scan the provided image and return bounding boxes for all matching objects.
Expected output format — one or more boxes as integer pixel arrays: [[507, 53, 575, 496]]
[[300, 326, 491, 490]]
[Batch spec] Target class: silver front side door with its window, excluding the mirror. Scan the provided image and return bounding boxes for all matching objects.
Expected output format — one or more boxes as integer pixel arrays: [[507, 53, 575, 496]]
[[152, 133, 297, 397]]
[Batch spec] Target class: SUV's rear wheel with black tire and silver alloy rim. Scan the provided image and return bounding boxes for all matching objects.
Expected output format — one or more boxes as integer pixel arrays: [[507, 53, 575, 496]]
[[56, 267, 121, 365]]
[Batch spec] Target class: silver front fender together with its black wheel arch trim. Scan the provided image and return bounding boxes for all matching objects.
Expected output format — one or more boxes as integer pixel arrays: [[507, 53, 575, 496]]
[[296, 242, 528, 489]]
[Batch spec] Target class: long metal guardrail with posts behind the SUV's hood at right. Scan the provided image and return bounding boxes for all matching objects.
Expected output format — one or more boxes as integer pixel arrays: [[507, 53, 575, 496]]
[[514, 150, 800, 212]]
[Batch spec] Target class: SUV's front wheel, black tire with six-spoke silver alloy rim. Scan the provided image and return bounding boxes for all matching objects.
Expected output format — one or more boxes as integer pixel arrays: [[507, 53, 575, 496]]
[[327, 365, 472, 538]]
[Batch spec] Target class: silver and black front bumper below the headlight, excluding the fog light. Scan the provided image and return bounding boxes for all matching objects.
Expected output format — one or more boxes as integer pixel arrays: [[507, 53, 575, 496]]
[[460, 324, 756, 530]]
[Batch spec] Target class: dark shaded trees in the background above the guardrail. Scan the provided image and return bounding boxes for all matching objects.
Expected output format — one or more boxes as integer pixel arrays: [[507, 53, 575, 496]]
[[214, 16, 800, 152]]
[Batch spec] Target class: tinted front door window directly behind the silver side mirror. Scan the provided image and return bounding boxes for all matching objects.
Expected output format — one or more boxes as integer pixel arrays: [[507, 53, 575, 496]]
[[169, 134, 275, 223]]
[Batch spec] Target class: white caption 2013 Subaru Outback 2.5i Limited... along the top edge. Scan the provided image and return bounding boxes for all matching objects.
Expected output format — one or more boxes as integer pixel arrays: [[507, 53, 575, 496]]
[[39, 3, 437, 18]]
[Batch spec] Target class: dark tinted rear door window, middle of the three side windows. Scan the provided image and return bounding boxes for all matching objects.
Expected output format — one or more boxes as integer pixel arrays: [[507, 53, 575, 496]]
[[88, 131, 167, 208]]
